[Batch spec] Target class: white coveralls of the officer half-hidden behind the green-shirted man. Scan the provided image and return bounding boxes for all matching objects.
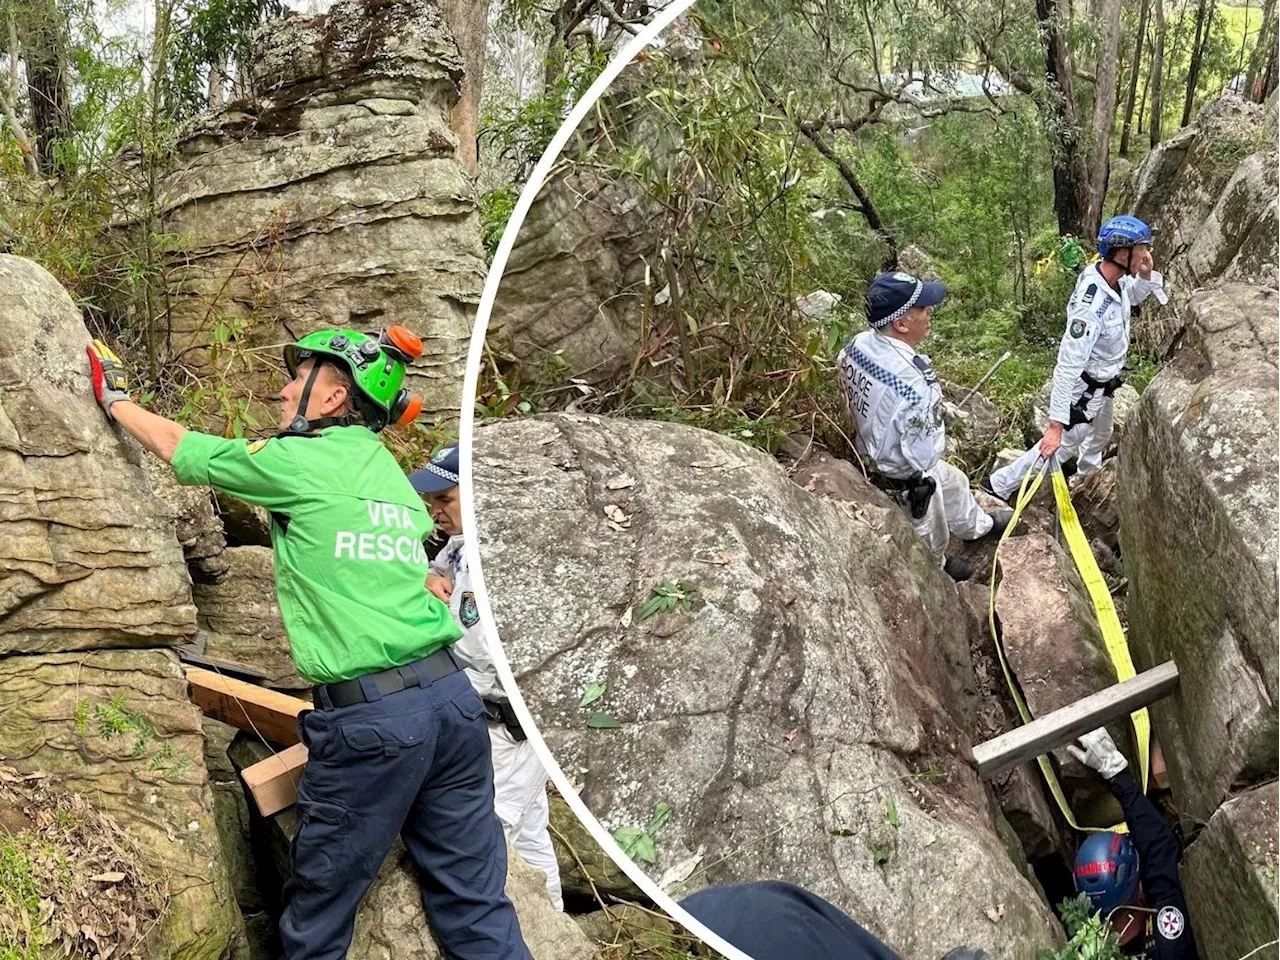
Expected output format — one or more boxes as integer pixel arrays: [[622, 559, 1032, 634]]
[[431, 535, 564, 910]]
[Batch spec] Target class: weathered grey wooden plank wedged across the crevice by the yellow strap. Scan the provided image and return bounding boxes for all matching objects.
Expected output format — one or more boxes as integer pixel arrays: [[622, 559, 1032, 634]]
[[973, 660, 1178, 780]]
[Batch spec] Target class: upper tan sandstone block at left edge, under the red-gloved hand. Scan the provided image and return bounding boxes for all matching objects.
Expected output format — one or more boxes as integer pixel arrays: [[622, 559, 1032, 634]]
[[0, 256, 196, 654]]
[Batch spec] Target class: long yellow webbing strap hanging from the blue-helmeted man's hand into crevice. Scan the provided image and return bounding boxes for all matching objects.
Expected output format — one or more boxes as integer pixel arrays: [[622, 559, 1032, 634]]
[[987, 454, 1151, 833]]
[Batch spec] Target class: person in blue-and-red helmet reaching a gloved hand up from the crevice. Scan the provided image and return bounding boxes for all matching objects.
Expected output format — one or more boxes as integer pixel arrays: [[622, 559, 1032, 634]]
[[1066, 727, 1197, 960]]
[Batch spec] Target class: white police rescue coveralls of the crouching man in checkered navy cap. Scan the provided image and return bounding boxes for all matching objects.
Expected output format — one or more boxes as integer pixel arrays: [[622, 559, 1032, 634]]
[[836, 330, 992, 564]]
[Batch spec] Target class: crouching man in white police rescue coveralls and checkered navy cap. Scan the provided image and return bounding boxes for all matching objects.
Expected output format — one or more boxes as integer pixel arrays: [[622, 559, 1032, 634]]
[[836, 273, 1012, 580]]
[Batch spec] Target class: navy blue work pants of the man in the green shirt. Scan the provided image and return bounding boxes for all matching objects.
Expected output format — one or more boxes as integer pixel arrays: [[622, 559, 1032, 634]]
[[280, 671, 531, 960]]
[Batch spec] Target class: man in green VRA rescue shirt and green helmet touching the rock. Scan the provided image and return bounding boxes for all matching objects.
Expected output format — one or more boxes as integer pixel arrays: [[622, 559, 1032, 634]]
[[88, 326, 530, 960]]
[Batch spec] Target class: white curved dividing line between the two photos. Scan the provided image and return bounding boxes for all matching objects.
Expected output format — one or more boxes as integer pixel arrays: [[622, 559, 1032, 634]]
[[458, 7, 751, 960]]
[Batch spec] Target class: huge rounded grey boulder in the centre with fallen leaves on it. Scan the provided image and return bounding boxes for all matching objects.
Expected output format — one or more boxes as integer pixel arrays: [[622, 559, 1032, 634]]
[[474, 415, 1061, 960]]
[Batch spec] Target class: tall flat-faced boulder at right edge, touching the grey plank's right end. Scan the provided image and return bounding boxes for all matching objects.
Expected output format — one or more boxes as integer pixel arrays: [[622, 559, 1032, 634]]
[[1117, 283, 1280, 822]]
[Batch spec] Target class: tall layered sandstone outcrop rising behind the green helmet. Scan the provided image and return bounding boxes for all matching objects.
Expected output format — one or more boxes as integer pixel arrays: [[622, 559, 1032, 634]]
[[145, 0, 485, 425]]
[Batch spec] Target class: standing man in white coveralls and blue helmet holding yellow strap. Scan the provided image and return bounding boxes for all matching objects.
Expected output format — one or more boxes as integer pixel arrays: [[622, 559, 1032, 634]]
[[983, 215, 1169, 500]]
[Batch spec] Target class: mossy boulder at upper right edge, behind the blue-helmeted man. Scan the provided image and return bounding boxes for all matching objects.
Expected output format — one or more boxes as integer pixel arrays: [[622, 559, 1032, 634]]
[[1132, 97, 1280, 356]]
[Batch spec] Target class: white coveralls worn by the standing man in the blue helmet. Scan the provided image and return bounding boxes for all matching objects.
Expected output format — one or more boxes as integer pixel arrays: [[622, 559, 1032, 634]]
[[991, 264, 1169, 500]]
